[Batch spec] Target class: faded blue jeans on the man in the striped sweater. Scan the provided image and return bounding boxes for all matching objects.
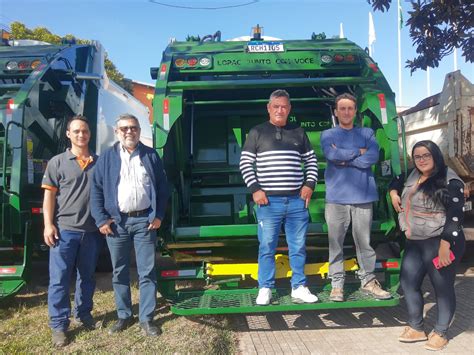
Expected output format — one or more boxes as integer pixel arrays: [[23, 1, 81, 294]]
[[257, 195, 309, 288]]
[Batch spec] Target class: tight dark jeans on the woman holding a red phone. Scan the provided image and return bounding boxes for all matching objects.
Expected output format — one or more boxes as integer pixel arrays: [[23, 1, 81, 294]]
[[400, 233, 466, 335]]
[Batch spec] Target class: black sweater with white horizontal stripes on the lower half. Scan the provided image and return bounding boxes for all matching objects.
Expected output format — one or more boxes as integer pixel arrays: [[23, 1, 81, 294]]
[[240, 121, 318, 196]]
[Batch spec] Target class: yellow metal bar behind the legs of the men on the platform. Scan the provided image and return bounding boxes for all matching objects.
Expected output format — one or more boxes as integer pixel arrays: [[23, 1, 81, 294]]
[[206, 254, 359, 280]]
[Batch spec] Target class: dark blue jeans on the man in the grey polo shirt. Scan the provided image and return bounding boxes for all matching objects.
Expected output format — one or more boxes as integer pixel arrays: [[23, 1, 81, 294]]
[[48, 230, 102, 331]]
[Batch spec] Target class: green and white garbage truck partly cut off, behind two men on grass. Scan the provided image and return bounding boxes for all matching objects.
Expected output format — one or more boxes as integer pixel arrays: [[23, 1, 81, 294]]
[[0, 35, 153, 300]]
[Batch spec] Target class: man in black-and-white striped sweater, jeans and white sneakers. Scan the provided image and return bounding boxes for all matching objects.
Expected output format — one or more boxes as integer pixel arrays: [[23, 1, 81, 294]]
[[240, 90, 318, 305]]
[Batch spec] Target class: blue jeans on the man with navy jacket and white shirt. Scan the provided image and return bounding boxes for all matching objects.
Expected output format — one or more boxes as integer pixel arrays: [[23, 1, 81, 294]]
[[107, 215, 156, 322]]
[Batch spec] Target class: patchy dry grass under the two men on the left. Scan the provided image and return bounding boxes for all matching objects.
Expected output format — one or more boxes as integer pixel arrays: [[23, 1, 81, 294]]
[[0, 274, 237, 354]]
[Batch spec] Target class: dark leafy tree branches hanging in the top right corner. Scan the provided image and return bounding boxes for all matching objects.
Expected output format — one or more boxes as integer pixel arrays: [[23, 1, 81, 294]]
[[367, 0, 474, 73]]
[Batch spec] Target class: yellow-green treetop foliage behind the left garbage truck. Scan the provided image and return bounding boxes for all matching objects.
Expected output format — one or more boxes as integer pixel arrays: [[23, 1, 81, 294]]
[[10, 22, 132, 93]]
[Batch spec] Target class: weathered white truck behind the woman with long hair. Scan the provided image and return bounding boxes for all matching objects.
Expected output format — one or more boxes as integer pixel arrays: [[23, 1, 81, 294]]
[[399, 70, 474, 240]]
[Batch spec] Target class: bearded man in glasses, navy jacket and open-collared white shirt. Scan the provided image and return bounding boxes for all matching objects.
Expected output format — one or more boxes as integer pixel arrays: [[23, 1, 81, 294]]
[[91, 114, 168, 336]]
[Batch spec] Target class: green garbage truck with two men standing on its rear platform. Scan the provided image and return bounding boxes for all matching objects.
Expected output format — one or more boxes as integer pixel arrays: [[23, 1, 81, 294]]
[[151, 26, 402, 315]]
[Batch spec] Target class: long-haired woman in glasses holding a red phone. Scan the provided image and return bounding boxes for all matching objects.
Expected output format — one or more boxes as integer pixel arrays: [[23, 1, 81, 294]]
[[389, 140, 465, 350]]
